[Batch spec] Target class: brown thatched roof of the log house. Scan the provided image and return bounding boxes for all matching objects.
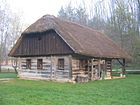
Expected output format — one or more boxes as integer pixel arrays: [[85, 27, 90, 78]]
[[9, 15, 129, 58]]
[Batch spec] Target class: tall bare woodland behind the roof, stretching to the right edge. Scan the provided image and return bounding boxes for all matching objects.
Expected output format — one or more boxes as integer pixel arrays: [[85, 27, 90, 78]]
[[57, 0, 140, 63]]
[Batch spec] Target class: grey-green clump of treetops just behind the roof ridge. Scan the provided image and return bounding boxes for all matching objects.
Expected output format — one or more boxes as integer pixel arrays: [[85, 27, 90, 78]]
[[58, 2, 88, 25]]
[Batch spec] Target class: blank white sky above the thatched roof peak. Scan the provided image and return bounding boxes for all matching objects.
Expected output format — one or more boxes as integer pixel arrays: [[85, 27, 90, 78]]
[[6, 0, 90, 24]]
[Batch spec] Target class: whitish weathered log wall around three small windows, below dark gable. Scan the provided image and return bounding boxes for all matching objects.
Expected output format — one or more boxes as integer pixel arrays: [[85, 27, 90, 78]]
[[20, 56, 71, 79]]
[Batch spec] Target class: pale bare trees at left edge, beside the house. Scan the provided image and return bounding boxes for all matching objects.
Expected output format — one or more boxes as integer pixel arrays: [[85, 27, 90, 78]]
[[0, 0, 22, 72]]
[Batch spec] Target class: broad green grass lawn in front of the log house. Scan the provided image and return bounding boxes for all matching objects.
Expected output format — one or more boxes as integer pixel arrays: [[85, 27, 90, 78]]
[[0, 75, 140, 105]]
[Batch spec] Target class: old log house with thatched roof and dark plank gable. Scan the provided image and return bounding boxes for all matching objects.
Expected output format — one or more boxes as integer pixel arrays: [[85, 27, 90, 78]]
[[9, 15, 129, 82]]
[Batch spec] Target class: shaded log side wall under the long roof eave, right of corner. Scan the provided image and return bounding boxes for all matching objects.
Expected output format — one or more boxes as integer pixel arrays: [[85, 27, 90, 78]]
[[72, 58, 105, 80]]
